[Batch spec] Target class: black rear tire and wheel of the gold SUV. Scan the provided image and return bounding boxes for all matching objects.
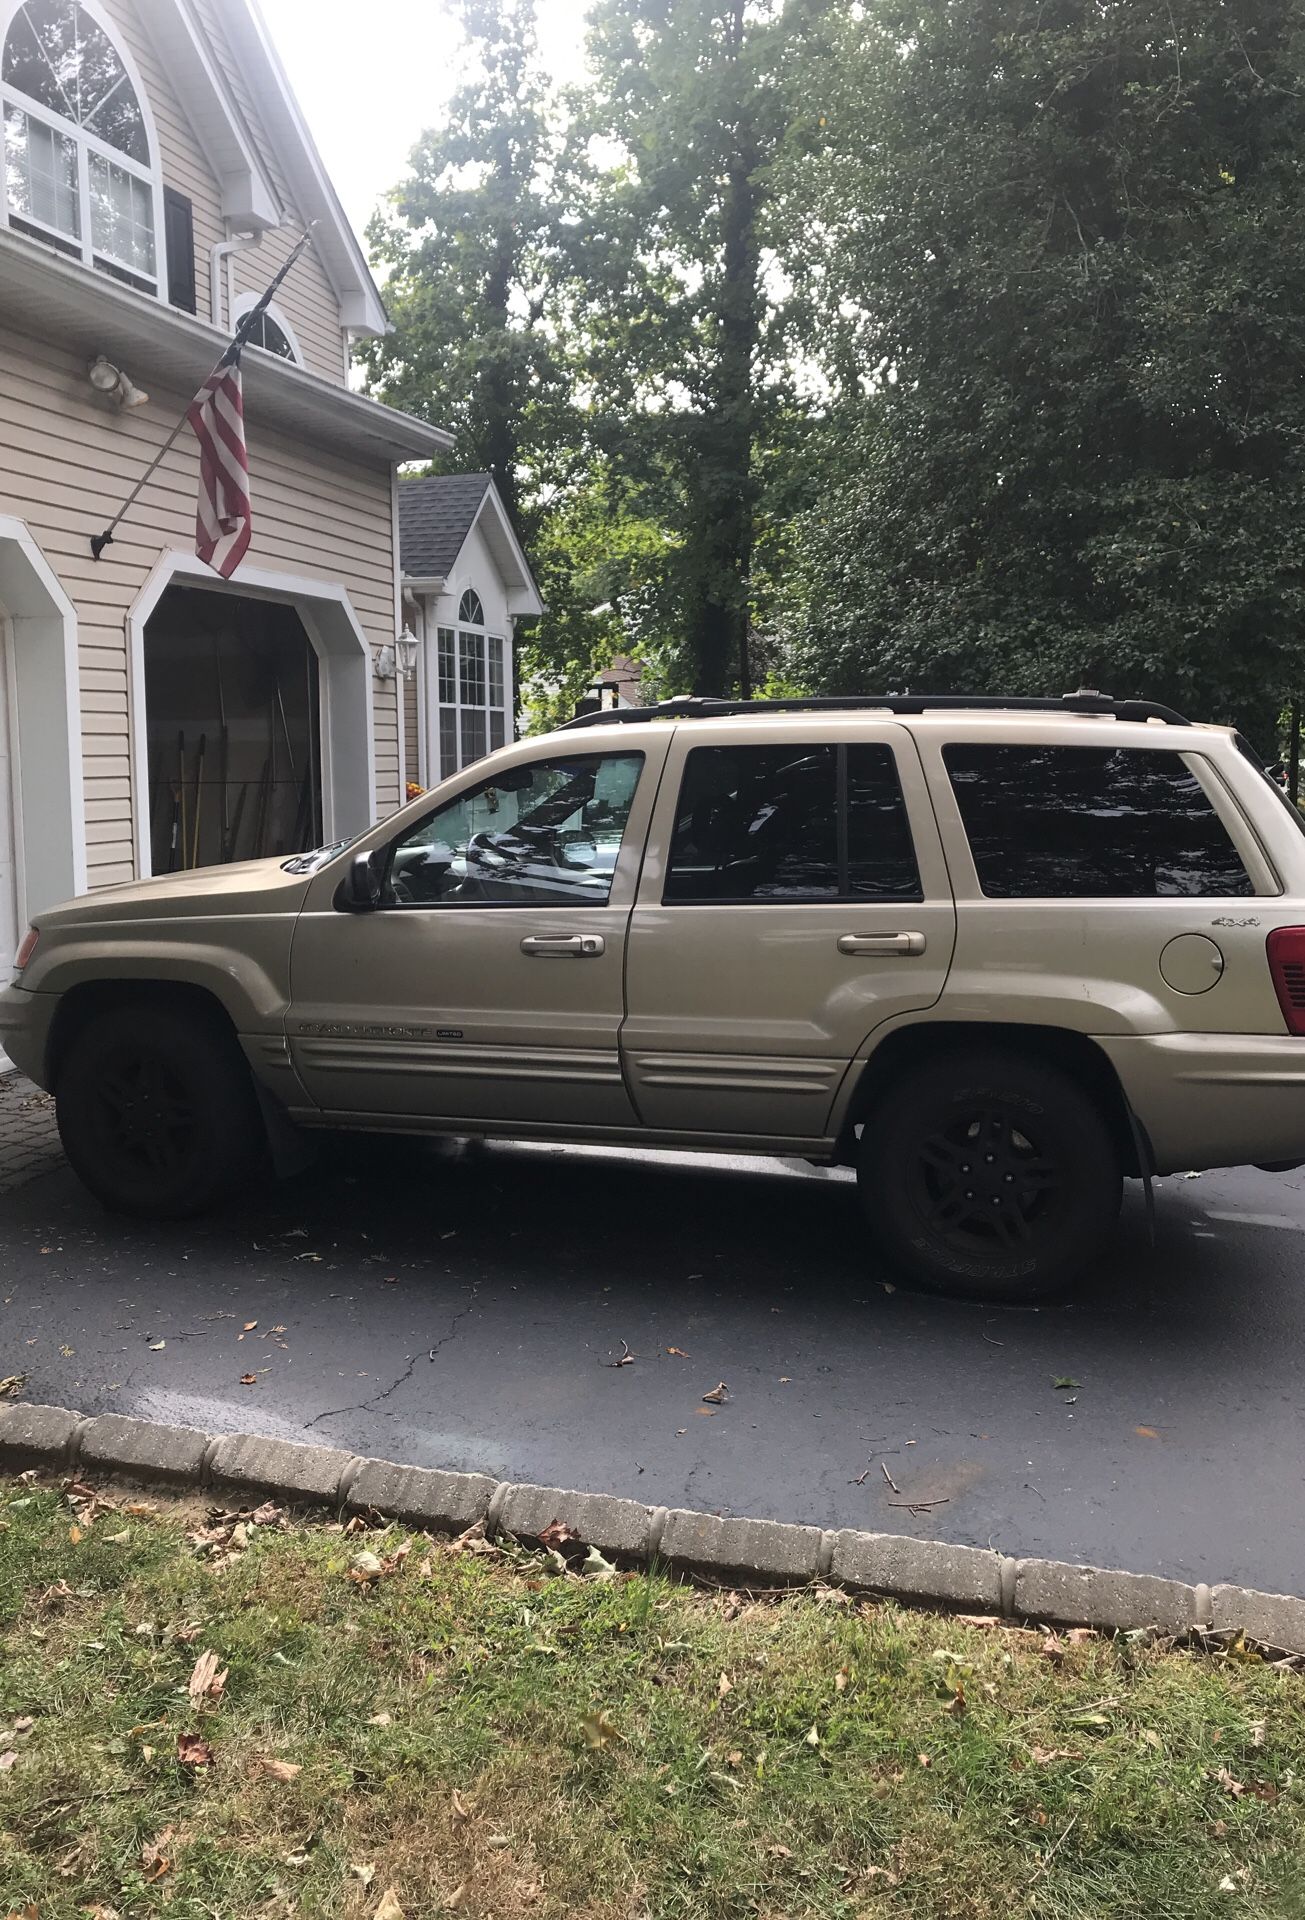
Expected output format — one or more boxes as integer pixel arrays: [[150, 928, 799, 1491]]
[[856, 1048, 1121, 1302]]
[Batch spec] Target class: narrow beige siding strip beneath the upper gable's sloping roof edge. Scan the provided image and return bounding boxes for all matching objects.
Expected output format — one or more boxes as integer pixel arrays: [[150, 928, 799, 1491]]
[[194, 0, 345, 386]]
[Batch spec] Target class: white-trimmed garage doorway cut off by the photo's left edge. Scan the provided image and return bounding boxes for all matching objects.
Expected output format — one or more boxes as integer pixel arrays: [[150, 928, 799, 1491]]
[[0, 515, 86, 922]]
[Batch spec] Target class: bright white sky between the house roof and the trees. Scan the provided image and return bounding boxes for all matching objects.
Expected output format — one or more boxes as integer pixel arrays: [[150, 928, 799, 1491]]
[[261, 0, 585, 245]]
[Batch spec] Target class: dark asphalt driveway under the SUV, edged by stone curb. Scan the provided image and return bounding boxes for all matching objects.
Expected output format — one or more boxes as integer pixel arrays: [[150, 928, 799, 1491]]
[[0, 1113, 1305, 1594]]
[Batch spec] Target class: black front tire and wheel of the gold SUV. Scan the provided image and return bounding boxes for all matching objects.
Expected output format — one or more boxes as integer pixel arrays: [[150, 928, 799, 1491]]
[[56, 1002, 267, 1219]]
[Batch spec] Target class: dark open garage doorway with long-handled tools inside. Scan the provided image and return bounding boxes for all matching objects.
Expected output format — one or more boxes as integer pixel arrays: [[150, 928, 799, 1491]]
[[144, 586, 324, 874]]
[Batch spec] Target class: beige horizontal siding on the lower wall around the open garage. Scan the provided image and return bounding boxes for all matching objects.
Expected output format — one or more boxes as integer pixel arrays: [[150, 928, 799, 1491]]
[[0, 334, 399, 887]]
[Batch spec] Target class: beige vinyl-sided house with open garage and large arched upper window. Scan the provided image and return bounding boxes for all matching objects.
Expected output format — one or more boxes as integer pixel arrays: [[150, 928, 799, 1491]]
[[0, 0, 449, 967]]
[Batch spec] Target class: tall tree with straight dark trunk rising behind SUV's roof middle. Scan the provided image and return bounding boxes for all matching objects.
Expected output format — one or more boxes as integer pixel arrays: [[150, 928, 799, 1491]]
[[570, 0, 821, 693]]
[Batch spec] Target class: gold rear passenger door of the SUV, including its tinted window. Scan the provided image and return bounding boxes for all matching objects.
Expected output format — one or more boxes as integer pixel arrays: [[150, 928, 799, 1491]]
[[622, 718, 956, 1140]]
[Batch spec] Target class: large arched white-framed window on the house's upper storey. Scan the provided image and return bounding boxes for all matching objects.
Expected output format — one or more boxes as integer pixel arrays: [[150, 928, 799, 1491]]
[[0, 0, 159, 294]]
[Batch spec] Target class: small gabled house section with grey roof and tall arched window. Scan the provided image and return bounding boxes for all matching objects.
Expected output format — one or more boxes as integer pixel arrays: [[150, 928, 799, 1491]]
[[399, 474, 543, 787]]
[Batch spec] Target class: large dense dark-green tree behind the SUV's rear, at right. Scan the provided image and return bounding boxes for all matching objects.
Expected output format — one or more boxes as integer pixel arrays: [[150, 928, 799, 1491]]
[[787, 0, 1305, 745]]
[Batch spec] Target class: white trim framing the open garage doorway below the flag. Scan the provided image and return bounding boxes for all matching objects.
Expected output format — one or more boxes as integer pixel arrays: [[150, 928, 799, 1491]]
[[125, 549, 376, 879]]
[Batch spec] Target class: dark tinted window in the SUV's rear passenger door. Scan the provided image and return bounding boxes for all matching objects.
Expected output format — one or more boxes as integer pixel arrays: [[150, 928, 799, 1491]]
[[662, 743, 921, 904]]
